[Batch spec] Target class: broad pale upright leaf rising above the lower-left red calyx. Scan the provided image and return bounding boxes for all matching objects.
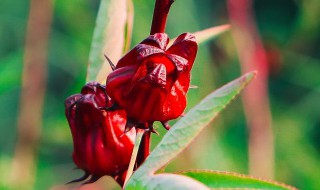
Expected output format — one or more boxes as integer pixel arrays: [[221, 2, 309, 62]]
[[86, 0, 127, 83]]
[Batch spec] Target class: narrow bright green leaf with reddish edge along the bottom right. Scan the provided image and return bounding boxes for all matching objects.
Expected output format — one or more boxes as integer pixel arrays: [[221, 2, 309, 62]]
[[179, 170, 295, 190]]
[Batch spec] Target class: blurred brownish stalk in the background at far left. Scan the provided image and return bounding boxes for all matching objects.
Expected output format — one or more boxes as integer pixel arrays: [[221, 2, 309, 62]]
[[10, 0, 53, 189]]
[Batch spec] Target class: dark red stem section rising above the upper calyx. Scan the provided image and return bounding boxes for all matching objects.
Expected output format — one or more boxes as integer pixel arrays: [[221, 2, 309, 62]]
[[150, 0, 174, 35]]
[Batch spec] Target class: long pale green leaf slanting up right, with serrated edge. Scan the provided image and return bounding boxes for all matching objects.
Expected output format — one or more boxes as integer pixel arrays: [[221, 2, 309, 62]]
[[127, 72, 256, 188]]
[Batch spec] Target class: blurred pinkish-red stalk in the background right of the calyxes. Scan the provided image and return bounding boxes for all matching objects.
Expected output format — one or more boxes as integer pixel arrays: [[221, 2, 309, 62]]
[[228, 0, 274, 178]]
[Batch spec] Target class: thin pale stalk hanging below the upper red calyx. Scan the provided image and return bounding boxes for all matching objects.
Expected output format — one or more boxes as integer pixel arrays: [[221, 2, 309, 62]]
[[123, 128, 145, 187]]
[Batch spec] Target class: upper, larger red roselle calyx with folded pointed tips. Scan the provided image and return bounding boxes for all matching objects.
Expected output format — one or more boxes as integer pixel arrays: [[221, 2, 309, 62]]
[[106, 33, 198, 123]]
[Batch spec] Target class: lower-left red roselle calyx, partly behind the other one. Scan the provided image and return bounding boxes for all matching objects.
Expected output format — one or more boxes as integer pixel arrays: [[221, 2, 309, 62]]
[[65, 82, 135, 185]]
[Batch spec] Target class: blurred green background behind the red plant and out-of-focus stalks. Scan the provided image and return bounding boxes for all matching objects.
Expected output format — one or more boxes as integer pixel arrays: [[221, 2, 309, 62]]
[[0, 0, 320, 190]]
